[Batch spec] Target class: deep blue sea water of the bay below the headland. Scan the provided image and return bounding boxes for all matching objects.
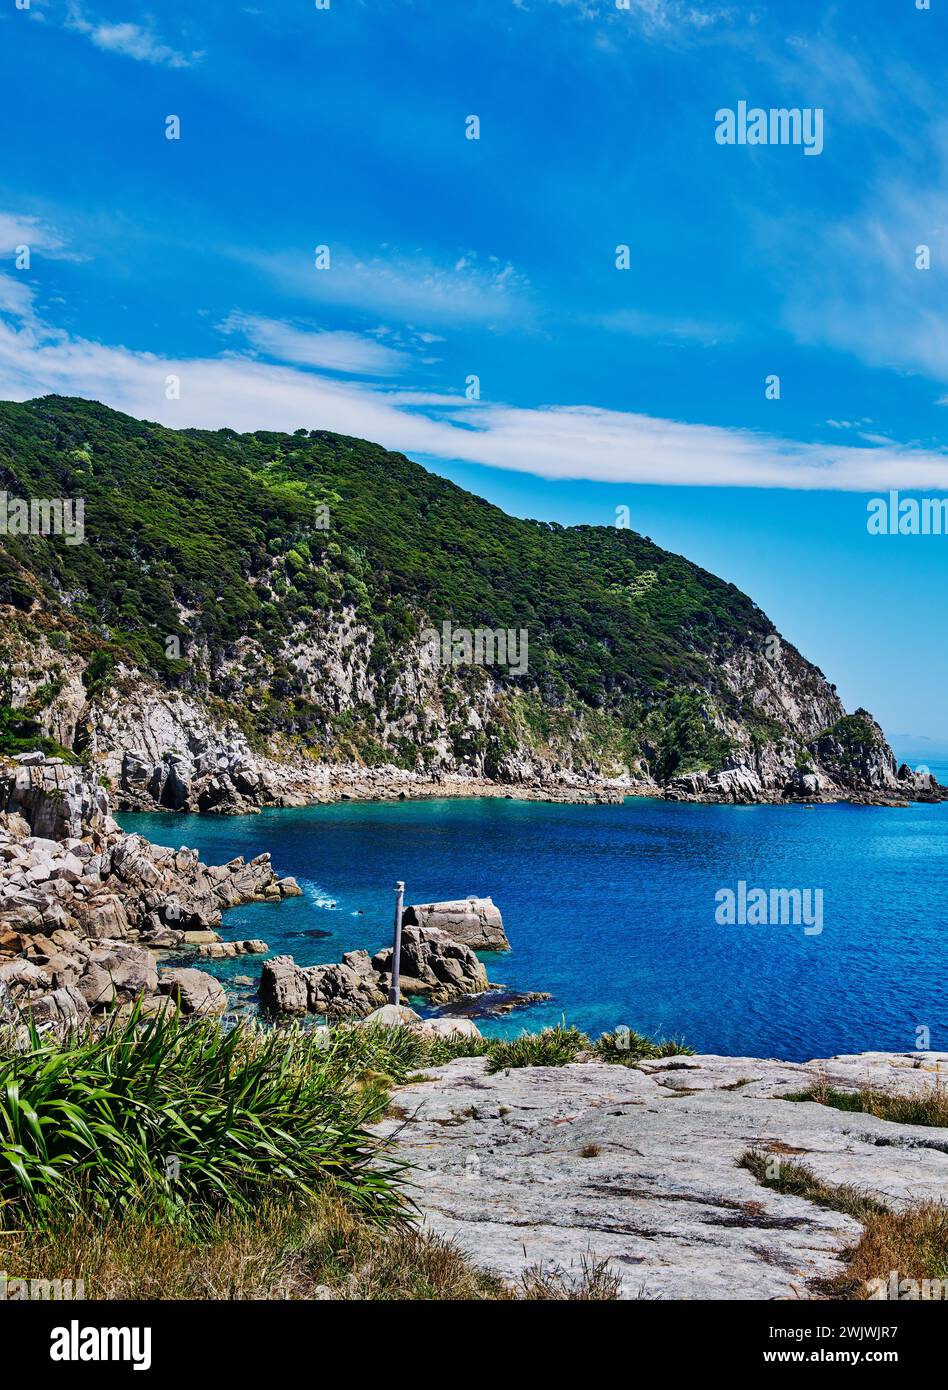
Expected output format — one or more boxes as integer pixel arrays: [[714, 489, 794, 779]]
[[120, 765, 948, 1061]]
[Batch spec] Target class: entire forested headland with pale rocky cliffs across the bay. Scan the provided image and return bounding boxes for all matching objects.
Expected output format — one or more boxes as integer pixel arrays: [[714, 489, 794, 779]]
[[0, 398, 917, 812]]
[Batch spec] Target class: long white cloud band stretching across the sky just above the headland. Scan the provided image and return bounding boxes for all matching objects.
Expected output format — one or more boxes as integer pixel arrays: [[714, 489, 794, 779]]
[[0, 275, 948, 491]]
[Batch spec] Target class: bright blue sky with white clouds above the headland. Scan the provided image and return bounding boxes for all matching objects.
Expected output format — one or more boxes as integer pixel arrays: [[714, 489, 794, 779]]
[[0, 0, 948, 756]]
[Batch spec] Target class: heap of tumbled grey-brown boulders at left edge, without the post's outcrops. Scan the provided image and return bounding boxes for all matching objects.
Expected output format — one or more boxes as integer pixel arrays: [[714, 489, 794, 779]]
[[0, 758, 299, 1027]]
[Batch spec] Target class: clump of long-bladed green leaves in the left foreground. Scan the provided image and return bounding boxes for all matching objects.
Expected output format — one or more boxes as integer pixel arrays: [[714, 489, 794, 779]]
[[0, 1013, 402, 1226]]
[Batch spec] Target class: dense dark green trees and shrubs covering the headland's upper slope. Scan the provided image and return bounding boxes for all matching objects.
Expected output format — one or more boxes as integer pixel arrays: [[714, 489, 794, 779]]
[[0, 396, 773, 776]]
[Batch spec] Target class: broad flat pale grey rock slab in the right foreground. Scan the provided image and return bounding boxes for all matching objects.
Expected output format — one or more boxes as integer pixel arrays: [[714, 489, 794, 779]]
[[369, 1054, 948, 1300]]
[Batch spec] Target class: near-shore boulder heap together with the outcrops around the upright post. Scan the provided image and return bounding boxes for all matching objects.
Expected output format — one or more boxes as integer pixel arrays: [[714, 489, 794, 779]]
[[0, 755, 537, 1033]]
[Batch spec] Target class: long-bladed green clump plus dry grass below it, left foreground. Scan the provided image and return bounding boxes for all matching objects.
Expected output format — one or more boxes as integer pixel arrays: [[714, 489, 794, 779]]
[[0, 1011, 633, 1300]]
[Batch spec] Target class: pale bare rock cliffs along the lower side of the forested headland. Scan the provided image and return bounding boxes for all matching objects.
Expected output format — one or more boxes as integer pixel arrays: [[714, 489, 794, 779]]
[[3, 586, 917, 813]]
